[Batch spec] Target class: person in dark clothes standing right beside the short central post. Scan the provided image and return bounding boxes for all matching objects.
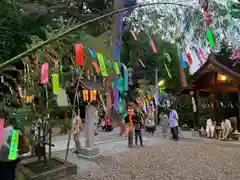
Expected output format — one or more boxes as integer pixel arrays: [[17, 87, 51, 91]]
[[133, 115, 144, 147]]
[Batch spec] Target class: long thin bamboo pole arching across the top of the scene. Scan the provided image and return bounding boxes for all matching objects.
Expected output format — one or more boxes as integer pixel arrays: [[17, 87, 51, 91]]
[[0, 2, 195, 69]]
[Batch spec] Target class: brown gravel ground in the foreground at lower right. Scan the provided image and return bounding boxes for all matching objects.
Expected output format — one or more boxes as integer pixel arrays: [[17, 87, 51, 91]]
[[66, 141, 240, 180]]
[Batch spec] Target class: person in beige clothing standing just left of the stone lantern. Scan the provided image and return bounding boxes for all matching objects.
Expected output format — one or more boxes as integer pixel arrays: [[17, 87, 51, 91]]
[[72, 112, 83, 154]]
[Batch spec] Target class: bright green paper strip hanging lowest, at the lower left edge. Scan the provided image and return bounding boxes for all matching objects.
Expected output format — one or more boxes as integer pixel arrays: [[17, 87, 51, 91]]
[[8, 130, 20, 160]]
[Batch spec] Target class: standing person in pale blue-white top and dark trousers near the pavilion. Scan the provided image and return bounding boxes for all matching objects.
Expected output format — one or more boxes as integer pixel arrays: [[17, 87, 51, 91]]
[[169, 106, 179, 141]]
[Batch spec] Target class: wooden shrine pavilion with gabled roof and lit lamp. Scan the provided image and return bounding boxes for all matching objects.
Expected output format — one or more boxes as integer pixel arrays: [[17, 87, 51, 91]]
[[182, 53, 240, 129]]
